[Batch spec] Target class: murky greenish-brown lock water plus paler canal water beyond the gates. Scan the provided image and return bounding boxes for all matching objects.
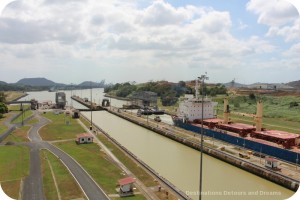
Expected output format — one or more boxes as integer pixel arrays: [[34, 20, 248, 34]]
[[19, 89, 294, 200]]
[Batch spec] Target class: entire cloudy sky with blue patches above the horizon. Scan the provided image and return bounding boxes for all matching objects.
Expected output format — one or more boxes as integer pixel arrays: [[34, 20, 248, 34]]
[[0, 0, 300, 84]]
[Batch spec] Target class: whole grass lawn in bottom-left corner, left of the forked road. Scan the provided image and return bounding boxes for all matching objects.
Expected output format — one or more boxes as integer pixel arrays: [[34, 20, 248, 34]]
[[0, 146, 29, 198]]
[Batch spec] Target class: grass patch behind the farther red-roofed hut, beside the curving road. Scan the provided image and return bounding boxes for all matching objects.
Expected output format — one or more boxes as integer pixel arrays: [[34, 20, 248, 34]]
[[39, 112, 84, 141]]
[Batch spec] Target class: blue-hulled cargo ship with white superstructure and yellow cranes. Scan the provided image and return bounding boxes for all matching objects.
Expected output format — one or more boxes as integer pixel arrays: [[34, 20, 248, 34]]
[[172, 80, 300, 164]]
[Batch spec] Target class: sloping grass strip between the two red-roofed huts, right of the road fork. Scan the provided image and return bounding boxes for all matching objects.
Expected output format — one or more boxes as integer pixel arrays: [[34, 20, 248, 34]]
[[56, 142, 124, 194]]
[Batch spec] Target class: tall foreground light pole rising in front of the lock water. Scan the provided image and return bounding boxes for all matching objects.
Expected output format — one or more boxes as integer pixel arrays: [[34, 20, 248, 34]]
[[196, 73, 208, 200]]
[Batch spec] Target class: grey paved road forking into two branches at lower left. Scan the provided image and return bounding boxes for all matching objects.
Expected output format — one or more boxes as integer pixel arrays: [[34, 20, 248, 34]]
[[23, 112, 109, 200]]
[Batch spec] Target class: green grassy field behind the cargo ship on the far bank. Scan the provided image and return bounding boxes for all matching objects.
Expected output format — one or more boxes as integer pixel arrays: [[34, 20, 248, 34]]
[[214, 95, 300, 134]]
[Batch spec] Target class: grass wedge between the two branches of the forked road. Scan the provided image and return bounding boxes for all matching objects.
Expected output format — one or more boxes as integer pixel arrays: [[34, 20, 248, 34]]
[[41, 150, 85, 200]]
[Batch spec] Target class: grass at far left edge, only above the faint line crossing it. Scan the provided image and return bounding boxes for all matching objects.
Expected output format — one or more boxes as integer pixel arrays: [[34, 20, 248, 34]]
[[0, 146, 29, 181]]
